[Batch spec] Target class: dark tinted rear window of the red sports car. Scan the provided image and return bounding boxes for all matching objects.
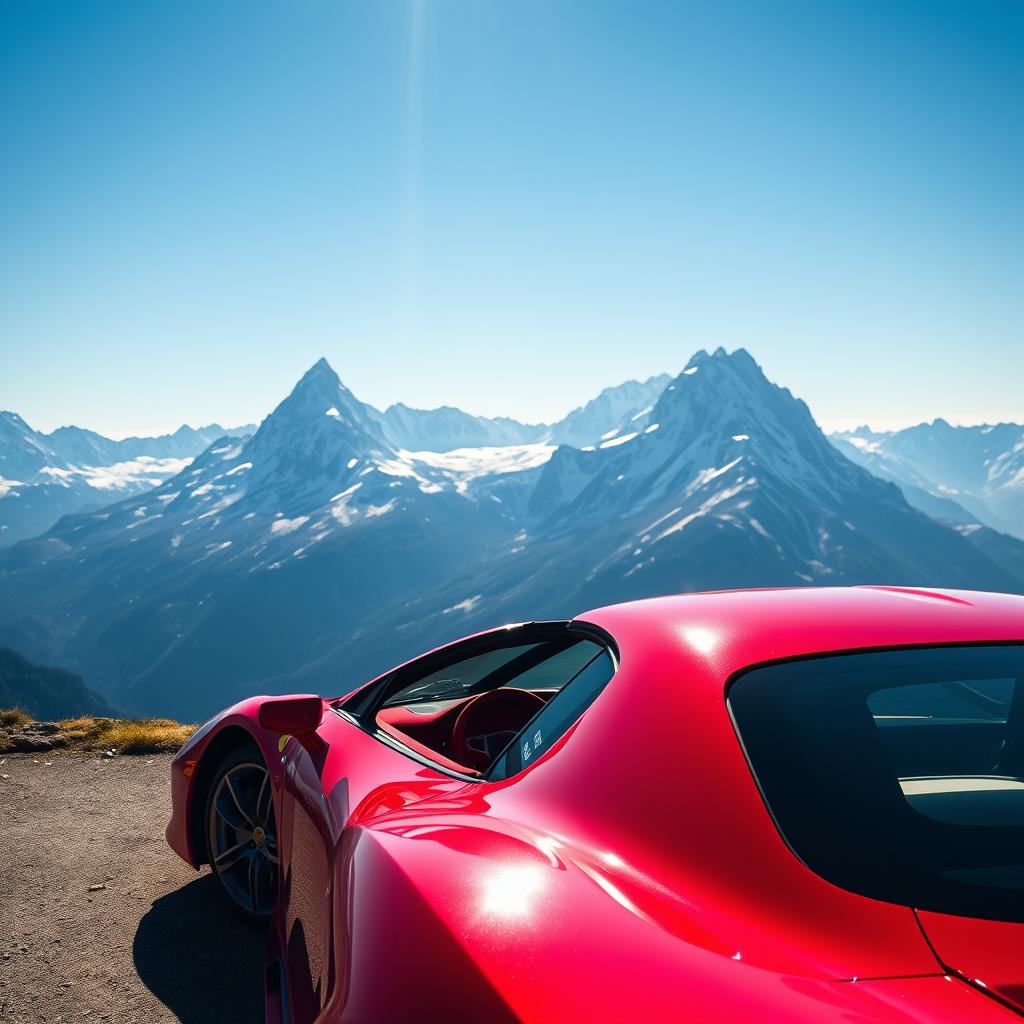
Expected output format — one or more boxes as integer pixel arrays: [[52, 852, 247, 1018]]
[[728, 645, 1024, 922]]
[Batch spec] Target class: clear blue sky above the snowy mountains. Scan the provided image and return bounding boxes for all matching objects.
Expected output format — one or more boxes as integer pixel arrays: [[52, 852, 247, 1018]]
[[0, 0, 1024, 434]]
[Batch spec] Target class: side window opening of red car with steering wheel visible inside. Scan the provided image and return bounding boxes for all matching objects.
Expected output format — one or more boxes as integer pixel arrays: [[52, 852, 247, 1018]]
[[352, 624, 614, 775]]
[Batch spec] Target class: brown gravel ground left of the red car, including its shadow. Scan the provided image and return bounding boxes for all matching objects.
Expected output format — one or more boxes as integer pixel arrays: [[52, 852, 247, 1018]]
[[0, 752, 264, 1024]]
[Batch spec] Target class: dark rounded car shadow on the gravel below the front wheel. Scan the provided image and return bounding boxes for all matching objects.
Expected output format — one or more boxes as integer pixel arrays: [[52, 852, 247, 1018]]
[[132, 874, 266, 1024]]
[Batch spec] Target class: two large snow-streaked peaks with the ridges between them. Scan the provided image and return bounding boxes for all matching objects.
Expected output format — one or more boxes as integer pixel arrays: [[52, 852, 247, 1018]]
[[0, 349, 1024, 719]]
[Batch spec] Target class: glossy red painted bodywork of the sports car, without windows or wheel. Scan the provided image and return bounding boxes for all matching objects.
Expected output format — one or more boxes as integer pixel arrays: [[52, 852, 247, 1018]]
[[167, 588, 1024, 1024]]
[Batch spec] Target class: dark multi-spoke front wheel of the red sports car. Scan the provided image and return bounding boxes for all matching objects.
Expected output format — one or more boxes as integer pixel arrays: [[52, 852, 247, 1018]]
[[206, 750, 280, 921]]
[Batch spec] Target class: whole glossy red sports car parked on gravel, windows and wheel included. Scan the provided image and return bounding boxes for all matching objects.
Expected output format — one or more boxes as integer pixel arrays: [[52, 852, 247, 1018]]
[[167, 587, 1024, 1024]]
